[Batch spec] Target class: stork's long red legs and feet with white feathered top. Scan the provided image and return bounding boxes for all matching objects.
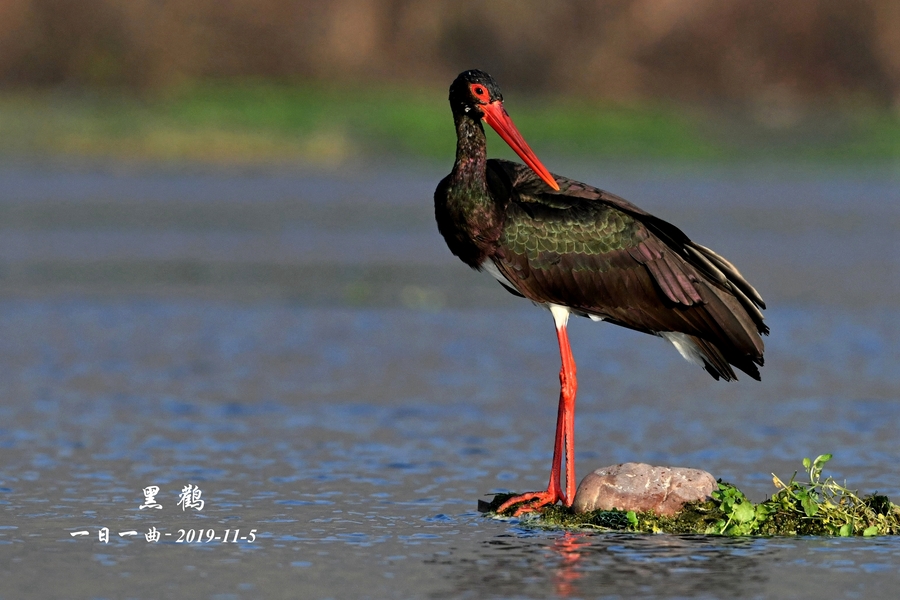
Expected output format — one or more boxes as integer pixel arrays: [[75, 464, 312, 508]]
[[497, 306, 578, 515]]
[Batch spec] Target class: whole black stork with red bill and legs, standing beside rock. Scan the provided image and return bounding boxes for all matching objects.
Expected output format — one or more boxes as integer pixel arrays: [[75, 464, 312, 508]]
[[434, 70, 769, 514]]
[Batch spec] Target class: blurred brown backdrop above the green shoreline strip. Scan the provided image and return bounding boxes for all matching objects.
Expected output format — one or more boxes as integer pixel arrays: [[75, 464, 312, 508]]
[[0, 0, 900, 107]]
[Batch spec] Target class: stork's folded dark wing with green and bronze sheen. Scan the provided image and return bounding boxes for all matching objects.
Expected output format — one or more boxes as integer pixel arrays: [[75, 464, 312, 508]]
[[490, 161, 766, 377]]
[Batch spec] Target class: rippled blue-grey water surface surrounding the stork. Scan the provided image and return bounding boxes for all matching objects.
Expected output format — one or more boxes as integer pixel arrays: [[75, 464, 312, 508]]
[[0, 167, 900, 598]]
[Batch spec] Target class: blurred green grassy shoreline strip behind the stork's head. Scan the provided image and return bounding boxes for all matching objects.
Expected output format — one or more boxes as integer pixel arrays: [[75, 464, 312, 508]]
[[0, 82, 900, 166]]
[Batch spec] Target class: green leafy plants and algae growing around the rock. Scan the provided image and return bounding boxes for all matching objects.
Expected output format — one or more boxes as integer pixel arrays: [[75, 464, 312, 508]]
[[484, 454, 900, 537]]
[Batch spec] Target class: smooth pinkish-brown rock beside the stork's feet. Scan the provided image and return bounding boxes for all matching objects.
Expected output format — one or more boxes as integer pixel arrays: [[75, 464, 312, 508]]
[[572, 463, 718, 516]]
